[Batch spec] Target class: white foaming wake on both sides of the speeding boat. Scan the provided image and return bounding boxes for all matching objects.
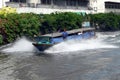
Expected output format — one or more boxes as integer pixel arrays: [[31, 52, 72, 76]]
[[0, 33, 120, 55]]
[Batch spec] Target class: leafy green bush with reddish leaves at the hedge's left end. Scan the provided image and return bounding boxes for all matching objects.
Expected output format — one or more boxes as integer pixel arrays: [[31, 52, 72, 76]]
[[0, 13, 40, 43]]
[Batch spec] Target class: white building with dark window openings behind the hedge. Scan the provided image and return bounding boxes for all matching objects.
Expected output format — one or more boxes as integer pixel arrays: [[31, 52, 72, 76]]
[[0, 0, 120, 14]]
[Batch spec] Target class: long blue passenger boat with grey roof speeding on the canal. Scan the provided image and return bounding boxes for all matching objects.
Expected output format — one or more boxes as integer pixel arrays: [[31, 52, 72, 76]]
[[32, 28, 95, 52]]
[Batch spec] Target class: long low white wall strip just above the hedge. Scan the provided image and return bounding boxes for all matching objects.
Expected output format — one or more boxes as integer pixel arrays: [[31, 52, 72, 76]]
[[17, 7, 91, 14]]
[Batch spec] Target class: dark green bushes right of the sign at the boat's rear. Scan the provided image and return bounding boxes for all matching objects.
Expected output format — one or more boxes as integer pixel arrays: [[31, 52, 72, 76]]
[[90, 12, 120, 31]]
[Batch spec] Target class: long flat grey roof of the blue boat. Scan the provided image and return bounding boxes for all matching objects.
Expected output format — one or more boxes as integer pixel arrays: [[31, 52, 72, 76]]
[[42, 28, 95, 37]]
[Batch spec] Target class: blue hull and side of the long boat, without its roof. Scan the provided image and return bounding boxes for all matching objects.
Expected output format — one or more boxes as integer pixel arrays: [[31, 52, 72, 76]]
[[33, 31, 95, 51]]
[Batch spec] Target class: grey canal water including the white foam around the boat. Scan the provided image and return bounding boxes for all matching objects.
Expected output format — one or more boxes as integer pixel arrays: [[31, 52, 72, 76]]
[[0, 32, 120, 80]]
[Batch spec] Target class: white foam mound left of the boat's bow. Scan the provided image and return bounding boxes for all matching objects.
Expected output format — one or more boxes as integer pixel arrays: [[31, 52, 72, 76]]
[[2, 37, 34, 53]]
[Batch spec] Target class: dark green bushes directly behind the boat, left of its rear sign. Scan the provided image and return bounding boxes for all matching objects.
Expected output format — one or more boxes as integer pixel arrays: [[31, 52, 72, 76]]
[[40, 12, 83, 34]]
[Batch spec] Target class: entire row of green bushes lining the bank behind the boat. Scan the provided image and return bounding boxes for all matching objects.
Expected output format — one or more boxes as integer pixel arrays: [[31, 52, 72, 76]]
[[0, 12, 120, 45]]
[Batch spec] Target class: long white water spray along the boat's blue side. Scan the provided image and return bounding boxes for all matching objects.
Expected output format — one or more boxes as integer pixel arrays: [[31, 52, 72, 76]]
[[46, 34, 118, 53]]
